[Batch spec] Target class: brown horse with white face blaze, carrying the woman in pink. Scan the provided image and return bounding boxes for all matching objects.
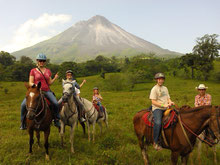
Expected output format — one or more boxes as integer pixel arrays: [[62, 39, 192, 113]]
[[25, 82, 52, 160]]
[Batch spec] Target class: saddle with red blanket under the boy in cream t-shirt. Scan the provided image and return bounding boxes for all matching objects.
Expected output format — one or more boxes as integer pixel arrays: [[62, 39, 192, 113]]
[[142, 109, 178, 129]]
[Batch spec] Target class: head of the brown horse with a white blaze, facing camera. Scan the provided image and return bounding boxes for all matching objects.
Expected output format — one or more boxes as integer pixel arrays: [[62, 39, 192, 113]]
[[25, 82, 41, 120]]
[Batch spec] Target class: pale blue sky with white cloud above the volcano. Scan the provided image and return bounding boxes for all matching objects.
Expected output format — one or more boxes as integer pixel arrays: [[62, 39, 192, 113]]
[[0, 0, 220, 53]]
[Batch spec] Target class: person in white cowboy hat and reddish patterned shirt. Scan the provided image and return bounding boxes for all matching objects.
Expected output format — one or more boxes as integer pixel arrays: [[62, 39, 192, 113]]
[[195, 84, 212, 107]]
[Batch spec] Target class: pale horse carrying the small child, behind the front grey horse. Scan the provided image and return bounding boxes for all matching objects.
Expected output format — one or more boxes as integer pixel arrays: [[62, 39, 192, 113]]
[[81, 98, 108, 142]]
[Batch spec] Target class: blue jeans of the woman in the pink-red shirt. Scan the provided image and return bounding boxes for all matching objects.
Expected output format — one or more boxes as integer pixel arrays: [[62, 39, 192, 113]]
[[21, 91, 60, 121]]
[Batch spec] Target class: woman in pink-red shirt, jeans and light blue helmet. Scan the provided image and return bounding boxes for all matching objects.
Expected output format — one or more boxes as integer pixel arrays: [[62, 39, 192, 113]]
[[20, 53, 60, 130]]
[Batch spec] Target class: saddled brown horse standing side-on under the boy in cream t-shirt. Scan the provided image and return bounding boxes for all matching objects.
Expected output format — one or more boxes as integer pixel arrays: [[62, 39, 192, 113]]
[[133, 106, 220, 164]]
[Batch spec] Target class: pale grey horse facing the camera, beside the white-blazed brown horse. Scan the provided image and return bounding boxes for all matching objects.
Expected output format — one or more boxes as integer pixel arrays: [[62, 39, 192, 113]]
[[60, 80, 78, 153]]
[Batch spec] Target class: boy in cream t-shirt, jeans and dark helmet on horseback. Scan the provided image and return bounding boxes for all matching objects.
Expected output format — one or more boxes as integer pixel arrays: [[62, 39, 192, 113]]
[[150, 73, 174, 150]]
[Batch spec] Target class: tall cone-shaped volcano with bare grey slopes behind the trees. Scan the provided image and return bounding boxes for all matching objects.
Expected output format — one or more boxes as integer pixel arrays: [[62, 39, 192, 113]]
[[12, 15, 180, 63]]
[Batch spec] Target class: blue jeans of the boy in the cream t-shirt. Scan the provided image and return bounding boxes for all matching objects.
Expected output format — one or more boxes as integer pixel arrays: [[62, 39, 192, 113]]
[[153, 109, 164, 144]]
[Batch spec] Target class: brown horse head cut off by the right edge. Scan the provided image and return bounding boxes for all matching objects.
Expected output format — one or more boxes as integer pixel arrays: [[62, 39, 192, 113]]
[[209, 106, 220, 141]]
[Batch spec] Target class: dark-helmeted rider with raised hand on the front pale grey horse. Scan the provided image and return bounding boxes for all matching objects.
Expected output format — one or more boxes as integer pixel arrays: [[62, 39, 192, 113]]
[[58, 70, 86, 122]]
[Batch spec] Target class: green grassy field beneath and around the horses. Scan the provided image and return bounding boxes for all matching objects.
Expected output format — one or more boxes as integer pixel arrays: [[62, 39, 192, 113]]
[[0, 75, 220, 165]]
